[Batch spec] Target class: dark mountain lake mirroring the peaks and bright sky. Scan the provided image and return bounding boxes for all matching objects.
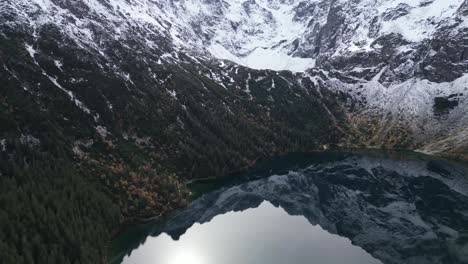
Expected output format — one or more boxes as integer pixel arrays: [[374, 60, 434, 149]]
[[112, 153, 468, 264]]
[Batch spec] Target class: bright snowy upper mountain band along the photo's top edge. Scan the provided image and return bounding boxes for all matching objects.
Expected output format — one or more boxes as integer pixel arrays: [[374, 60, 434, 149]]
[[0, 0, 468, 71]]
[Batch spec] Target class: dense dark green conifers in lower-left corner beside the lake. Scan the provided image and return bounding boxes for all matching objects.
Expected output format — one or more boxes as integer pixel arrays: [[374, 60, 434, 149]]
[[0, 143, 119, 263]]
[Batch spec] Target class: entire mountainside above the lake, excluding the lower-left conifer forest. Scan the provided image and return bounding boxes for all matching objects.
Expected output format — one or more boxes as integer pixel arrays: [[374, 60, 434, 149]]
[[0, 0, 468, 263]]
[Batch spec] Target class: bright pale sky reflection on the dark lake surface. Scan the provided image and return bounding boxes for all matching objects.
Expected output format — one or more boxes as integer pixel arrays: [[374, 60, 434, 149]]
[[123, 202, 381, 264]]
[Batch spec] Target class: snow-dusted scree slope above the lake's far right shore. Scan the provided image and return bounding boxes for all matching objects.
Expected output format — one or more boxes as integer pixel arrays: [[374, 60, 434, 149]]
[[321, 72, 468, 154]]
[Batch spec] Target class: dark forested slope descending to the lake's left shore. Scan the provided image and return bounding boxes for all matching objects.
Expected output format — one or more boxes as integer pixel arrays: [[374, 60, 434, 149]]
[[0, 21, 341, 264]]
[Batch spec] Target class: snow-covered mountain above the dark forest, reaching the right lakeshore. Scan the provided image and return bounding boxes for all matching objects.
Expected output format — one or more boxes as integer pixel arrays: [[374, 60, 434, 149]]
[[0, 0, 468, 161]]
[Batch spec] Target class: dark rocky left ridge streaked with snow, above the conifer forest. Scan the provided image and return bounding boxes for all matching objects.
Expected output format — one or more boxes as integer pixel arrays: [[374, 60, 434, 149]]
[[0, 1, 352, 177]]
